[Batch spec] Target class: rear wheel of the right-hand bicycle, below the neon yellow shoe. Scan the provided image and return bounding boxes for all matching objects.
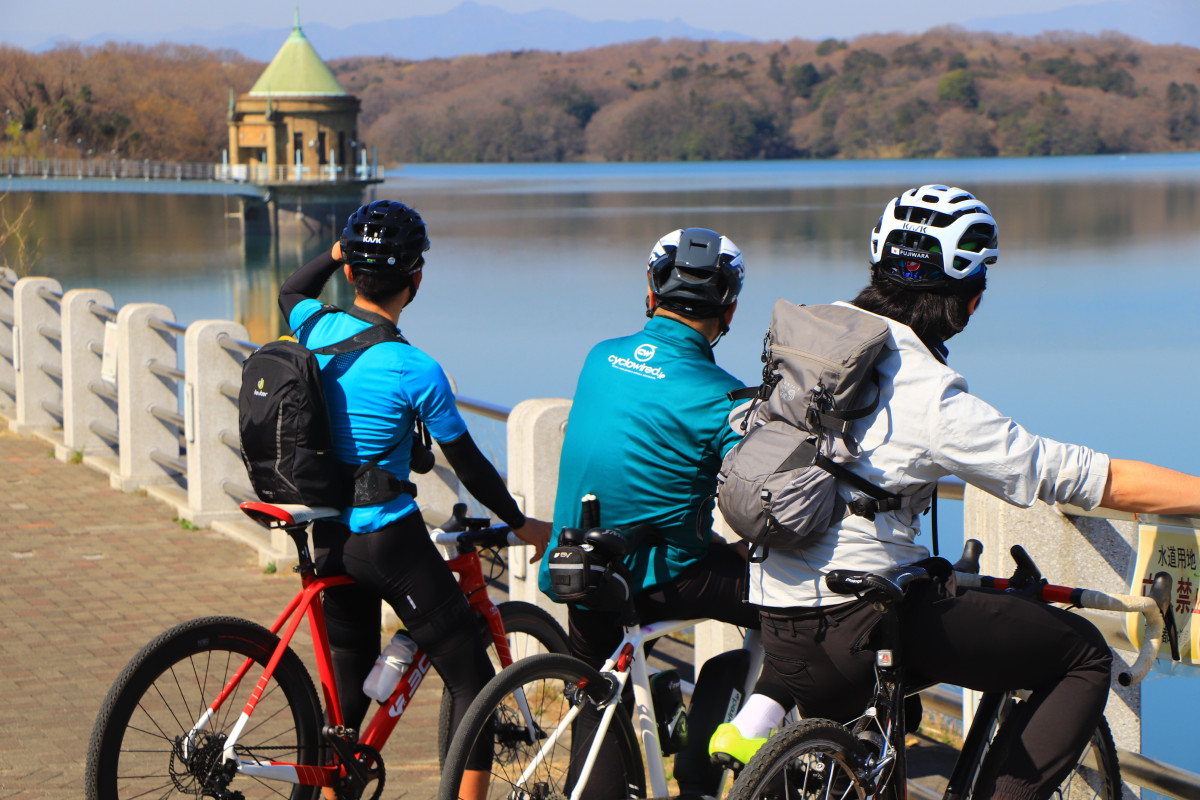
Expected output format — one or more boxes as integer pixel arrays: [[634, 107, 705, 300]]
[[728, 720, 866, 800]]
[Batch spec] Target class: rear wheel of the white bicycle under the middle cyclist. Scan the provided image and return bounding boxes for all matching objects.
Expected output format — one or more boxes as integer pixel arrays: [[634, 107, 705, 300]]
[[438, 654, 646, 800]]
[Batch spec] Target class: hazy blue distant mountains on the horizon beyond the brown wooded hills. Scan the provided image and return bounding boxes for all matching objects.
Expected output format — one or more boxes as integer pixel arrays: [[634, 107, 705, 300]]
[[0, 0, 1200, 61]]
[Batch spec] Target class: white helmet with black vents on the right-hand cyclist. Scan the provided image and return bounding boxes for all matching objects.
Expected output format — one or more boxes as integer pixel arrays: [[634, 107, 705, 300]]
[[871, 184, 1000, 288]]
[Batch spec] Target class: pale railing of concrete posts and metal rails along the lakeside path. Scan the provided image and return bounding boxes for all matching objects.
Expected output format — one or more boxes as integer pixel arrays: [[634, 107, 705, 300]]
[[0, 267, 1200, 800]]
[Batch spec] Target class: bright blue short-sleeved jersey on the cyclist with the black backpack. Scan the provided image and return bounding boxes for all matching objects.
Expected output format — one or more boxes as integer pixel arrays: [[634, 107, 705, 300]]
[[288, 300, 467, 534]]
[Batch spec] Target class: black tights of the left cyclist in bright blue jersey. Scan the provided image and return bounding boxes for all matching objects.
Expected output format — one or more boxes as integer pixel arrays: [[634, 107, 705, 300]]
[[313, 512, 496, 770]]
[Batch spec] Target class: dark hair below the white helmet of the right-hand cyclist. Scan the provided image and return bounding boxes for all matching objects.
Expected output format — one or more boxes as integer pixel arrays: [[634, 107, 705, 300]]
[[852, 265, 988, 354]]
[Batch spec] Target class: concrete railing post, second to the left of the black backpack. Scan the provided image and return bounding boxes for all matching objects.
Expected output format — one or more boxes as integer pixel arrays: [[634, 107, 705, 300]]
[[112, 302, 179, 492]]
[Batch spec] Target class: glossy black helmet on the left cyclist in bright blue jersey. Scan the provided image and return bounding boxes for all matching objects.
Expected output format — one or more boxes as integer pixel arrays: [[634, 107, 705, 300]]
[[341, 200, 430, 276]]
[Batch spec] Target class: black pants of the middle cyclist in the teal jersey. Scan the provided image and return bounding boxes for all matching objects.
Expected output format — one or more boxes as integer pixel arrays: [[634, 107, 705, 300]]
[[568, 542, 791, 798]]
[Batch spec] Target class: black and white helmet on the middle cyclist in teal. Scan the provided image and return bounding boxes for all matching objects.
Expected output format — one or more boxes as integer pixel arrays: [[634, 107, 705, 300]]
[[647, 228, 745, 319]]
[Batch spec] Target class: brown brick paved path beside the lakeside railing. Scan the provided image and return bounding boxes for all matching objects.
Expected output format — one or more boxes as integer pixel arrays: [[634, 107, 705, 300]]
[[0, 431, 442, 800]]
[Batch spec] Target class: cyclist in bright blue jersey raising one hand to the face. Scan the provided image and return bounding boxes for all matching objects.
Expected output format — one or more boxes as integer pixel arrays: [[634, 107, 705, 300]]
[[280, 200, 550, 800]]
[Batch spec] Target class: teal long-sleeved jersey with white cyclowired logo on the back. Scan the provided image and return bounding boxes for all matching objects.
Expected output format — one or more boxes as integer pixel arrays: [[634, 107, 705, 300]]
[[538, 317, 743, 596]]
